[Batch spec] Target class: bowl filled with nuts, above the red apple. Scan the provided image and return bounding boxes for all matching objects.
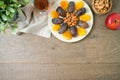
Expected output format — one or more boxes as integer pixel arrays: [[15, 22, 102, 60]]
[[92, 0, 112, 14]]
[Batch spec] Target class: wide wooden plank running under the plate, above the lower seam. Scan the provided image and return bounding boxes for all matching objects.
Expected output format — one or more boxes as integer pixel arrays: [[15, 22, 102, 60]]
[[0, 0, 120, 63]]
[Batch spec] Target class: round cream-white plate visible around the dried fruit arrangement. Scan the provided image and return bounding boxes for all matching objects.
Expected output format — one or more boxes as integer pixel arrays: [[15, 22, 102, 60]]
[[48, 0, 93, 42]]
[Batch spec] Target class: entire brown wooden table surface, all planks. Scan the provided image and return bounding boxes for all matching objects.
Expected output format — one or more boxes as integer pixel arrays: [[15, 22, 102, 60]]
[[0, 0, 120, 80]]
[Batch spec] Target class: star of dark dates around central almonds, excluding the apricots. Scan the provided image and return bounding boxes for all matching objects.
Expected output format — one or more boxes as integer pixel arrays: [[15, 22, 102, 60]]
[[52, 1, 88, 37]]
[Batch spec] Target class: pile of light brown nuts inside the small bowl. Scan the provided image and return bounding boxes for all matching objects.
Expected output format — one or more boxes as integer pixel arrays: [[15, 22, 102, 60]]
[[93, 0, 112, 14]]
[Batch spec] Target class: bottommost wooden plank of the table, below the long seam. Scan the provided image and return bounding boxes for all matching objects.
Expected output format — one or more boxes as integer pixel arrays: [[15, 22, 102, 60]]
[[0, 64, 120, 80]]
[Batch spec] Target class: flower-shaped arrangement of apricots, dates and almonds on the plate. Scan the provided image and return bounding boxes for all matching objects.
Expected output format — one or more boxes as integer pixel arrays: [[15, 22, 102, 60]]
[[51, 0, 90, 40]]
